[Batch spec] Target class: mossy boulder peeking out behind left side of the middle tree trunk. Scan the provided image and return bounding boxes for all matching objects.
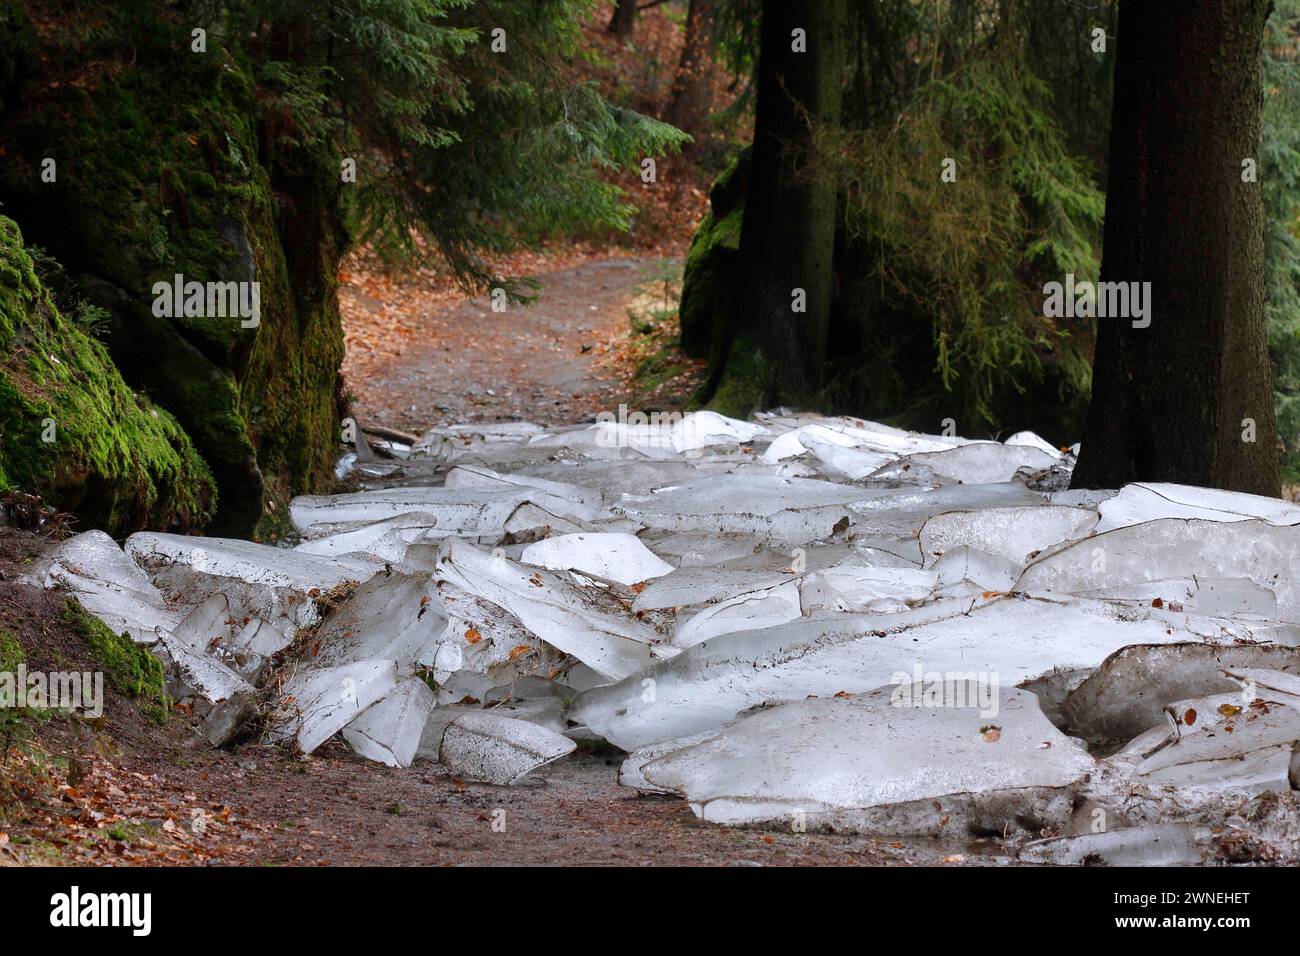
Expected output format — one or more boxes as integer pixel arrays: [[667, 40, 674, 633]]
[[679, 148, 751, 359]]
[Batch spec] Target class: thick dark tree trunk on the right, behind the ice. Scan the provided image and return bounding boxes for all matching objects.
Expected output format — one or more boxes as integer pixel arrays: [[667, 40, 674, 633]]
[[1073, 0, 1279, 494]]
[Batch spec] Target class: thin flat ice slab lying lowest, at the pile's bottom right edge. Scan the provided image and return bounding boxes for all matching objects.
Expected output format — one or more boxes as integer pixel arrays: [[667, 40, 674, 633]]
[[1018, 823, 1210, 866]]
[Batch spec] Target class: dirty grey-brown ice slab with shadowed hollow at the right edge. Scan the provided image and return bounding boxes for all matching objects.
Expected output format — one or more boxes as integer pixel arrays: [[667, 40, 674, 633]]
[[1061, 641, 1300, 744]]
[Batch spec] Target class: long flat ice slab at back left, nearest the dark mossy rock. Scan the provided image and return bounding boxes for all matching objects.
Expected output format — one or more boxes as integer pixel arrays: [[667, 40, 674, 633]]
[[289, 485, 542, 537]]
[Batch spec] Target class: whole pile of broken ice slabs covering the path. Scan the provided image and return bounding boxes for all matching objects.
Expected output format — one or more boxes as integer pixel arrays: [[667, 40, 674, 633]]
[[31, 412, 1300, 862]]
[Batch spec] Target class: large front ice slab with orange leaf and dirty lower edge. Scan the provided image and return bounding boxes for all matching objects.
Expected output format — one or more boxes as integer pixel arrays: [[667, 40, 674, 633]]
[[641, 683, 1093, 836]]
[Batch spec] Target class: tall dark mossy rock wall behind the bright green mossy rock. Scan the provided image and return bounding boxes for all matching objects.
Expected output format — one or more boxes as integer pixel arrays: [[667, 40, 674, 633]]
[[0, 0, 347, 536]]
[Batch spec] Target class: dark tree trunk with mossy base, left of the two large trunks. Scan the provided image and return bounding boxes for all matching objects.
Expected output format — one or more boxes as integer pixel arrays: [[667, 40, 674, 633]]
[[699, 0, 848, 416]]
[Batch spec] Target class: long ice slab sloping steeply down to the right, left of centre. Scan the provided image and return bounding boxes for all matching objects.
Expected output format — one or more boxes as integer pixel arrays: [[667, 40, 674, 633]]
[[437, 540, 675, 679]]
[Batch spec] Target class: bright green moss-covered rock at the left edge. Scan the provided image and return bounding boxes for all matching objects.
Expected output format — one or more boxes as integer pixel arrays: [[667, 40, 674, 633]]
[[0, 217, 216, 536]]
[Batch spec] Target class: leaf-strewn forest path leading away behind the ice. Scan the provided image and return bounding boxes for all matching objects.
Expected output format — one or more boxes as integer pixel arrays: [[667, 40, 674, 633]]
[[341, 258, 666, 433]]
